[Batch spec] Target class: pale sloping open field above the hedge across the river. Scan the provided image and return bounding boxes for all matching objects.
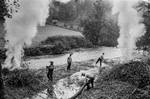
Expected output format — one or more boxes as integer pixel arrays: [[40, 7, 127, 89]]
[[0, 23, 82, 48]]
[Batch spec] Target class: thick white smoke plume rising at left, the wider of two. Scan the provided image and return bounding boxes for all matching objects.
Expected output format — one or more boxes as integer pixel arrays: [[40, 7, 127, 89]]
[[4, 0, 50, 69]]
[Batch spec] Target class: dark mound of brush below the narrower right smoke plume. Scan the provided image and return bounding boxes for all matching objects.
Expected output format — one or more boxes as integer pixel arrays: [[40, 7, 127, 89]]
[[104, 61, 150, 88]]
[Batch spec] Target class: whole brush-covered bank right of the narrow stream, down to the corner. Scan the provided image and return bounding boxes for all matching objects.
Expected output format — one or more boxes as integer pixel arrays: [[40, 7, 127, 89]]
[[79, 61, 150, 99]]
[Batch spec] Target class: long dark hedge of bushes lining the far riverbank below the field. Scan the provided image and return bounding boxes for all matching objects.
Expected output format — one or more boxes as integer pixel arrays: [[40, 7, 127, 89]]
[[24, 36, 92, 56]]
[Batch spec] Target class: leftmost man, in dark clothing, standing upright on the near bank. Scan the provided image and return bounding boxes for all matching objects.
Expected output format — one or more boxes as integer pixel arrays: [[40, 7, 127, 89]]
[[46, 61, 54, 81]]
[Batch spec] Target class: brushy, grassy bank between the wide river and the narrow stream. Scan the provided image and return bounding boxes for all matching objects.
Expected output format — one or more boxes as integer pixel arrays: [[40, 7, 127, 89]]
[[3, 61, 93, 99]]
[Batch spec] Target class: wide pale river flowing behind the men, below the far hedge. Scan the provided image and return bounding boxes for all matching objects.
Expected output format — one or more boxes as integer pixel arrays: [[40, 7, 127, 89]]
[[27, 47, 122, 69]]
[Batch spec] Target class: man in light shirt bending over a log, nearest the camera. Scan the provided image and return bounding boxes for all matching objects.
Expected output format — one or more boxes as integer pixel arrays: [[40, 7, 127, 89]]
[[81, 73, 95, 89]]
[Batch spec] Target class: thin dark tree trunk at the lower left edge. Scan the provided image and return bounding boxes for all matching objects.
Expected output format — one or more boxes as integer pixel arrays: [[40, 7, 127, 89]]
[[0, 60, 5, 99]]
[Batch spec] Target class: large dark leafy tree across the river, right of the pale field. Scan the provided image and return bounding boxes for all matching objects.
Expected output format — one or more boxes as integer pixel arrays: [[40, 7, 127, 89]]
[[81, 0, 119, 46]]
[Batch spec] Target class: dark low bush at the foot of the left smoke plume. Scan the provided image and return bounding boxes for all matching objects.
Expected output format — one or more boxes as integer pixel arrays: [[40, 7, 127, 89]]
[[2, 68, 42, 88]]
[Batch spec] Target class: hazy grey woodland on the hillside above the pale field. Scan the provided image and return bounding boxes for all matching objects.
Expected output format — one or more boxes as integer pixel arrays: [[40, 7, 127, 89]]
[[47, 0, 95, 23]]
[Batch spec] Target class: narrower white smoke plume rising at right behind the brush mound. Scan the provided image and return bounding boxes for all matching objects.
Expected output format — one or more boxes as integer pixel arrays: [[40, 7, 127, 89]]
[[112, 0, 145, 62]]
